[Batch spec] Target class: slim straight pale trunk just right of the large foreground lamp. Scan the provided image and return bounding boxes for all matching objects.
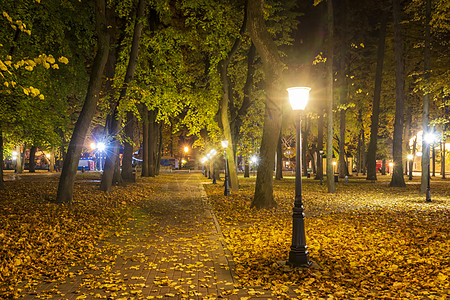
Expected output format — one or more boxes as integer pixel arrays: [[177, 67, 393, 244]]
[[326, 0, 336, 193]]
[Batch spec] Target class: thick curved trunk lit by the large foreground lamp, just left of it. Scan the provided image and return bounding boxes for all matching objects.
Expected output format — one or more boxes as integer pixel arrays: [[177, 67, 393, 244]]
[[247, 0, 287, 209]]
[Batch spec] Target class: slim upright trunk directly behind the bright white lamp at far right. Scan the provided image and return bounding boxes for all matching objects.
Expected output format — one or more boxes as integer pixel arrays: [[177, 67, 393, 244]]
[[420, 0, 431, 193]]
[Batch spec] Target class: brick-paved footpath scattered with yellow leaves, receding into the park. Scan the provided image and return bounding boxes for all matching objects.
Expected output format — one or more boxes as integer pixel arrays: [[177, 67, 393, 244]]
[[22, 174, 256, 300]]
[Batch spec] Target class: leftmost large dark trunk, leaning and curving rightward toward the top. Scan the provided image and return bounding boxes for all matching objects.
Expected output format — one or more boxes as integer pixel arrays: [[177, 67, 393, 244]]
[[56, 0, 110, 204]]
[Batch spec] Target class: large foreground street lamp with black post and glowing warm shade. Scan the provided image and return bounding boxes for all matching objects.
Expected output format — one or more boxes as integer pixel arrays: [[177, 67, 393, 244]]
[[287, 87, 312, 267]]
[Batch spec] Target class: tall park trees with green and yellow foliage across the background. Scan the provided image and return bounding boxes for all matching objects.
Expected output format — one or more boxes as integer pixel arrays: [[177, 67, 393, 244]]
[[0, 0, 449, 208]]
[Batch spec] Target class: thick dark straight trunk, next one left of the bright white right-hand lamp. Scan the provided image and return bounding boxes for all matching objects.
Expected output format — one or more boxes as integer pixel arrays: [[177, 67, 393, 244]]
[[389, 0, 406, 187]]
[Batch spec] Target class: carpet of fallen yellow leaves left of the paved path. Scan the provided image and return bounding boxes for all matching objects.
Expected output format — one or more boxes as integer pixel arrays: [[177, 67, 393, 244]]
[[0, 173, 156, 299]]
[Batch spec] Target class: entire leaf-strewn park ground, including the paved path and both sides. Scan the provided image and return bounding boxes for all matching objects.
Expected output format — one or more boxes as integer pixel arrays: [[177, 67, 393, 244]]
[[0, 173, 450, 300]]
